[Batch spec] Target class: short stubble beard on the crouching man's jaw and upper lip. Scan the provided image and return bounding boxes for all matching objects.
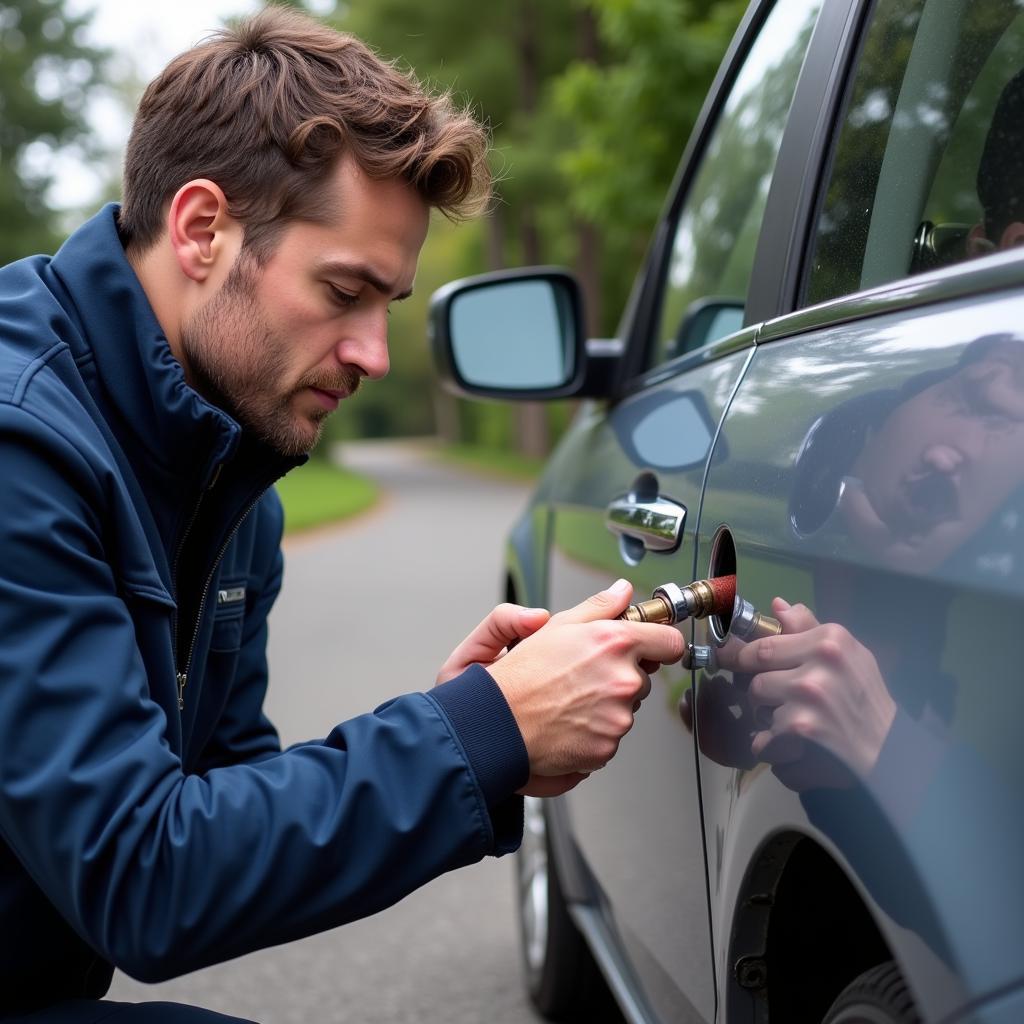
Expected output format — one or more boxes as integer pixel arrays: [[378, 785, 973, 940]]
[[181, 253, 361, 458]]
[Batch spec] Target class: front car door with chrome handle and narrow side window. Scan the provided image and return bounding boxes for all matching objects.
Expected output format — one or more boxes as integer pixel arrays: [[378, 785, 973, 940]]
[[547, 0, 818, 1020]]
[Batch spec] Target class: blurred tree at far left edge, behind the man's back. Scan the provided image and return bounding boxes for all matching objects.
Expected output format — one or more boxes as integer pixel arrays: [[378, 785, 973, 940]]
[[0, 0, 105, 264]]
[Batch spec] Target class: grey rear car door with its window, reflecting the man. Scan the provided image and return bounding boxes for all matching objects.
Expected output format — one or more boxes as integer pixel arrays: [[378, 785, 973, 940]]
[[694, 0, 1024, 1020]]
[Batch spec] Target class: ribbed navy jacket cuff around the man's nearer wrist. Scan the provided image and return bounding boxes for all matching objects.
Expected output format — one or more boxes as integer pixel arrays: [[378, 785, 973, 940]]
[[430, 665, 529, 811]]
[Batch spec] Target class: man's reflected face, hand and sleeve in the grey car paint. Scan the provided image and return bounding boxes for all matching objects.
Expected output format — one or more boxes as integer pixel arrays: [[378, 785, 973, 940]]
[[684, 335, 1024, 985]]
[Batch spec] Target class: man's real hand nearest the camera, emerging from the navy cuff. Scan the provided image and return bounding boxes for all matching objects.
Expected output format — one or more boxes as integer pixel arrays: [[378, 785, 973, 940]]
[[487, 580, 683, 797]]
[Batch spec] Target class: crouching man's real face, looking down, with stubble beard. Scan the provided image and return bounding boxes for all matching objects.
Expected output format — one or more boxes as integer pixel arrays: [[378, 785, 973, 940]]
[[181, 160, 429, 456]]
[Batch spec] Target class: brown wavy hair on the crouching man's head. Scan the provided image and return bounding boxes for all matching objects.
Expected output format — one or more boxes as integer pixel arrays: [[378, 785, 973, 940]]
[[119, 7, 492, 258]]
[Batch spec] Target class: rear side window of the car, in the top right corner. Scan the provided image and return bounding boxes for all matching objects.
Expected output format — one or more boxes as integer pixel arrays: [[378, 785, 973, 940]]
[[804, 0, 1024, 303]]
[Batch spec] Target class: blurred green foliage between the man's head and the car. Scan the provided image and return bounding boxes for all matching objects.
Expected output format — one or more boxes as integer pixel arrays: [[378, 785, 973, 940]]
[[311, 0, 746, 449]]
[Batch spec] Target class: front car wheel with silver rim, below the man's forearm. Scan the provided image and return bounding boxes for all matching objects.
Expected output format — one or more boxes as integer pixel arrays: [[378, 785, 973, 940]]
[[516, 797, 623, 1024]]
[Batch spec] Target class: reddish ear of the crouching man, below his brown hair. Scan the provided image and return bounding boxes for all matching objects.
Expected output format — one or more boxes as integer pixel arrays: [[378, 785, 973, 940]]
[[167, 178, 242, 284]]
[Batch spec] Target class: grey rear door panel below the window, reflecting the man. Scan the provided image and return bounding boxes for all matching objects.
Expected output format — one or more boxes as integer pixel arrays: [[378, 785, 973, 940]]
[[696, 288, 1024, 1020]]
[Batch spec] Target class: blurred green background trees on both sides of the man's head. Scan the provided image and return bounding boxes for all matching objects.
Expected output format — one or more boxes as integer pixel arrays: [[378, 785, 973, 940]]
[[0, 0, 746, 455]]
